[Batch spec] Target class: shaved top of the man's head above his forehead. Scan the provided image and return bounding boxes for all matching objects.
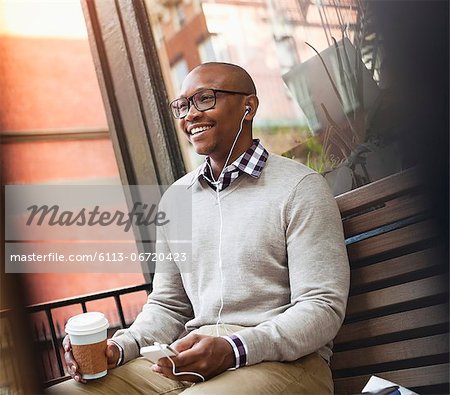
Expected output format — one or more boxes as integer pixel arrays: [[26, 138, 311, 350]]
[[189, 62, 256, 95]]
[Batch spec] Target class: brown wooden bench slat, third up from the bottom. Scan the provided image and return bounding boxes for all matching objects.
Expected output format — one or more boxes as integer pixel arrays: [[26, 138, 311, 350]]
[[334, 303, 449, 345]]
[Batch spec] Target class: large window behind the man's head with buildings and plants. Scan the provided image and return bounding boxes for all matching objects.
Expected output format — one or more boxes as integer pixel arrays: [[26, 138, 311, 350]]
[[147, 0, 426, 194]]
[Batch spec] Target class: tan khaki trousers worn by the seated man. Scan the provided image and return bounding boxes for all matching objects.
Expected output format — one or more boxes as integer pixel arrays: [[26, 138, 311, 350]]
[[47, 326, 333, 395]]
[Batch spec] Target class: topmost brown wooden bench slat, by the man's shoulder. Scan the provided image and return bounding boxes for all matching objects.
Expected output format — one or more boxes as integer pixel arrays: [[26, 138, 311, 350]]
[[336, 168, 421, 217]]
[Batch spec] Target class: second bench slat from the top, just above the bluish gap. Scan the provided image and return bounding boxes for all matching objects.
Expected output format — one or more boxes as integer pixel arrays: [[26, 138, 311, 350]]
[[343, 195, 430, 237]]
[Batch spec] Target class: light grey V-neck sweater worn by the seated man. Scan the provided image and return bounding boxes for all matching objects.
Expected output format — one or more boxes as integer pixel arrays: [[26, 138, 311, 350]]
[[114, 154, 349, 364]]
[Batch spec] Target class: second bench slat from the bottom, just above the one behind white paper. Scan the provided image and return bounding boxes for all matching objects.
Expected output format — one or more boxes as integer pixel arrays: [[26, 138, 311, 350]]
[[331, 333, 449, 371]]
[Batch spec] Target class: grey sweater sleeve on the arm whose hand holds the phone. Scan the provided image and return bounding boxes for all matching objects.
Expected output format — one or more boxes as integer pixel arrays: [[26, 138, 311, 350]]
[[238, 173, 350, 365]]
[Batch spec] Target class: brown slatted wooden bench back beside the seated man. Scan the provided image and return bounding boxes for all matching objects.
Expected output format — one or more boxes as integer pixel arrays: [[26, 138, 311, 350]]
[[331, 169, 449, 394]]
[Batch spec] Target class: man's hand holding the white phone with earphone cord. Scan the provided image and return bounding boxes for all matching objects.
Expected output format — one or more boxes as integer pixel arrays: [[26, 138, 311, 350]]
[[152, 334, 235, 382]]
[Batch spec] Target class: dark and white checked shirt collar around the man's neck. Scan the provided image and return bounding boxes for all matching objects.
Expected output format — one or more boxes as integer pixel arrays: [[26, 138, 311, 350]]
[[197, 139, 269, 191]]
